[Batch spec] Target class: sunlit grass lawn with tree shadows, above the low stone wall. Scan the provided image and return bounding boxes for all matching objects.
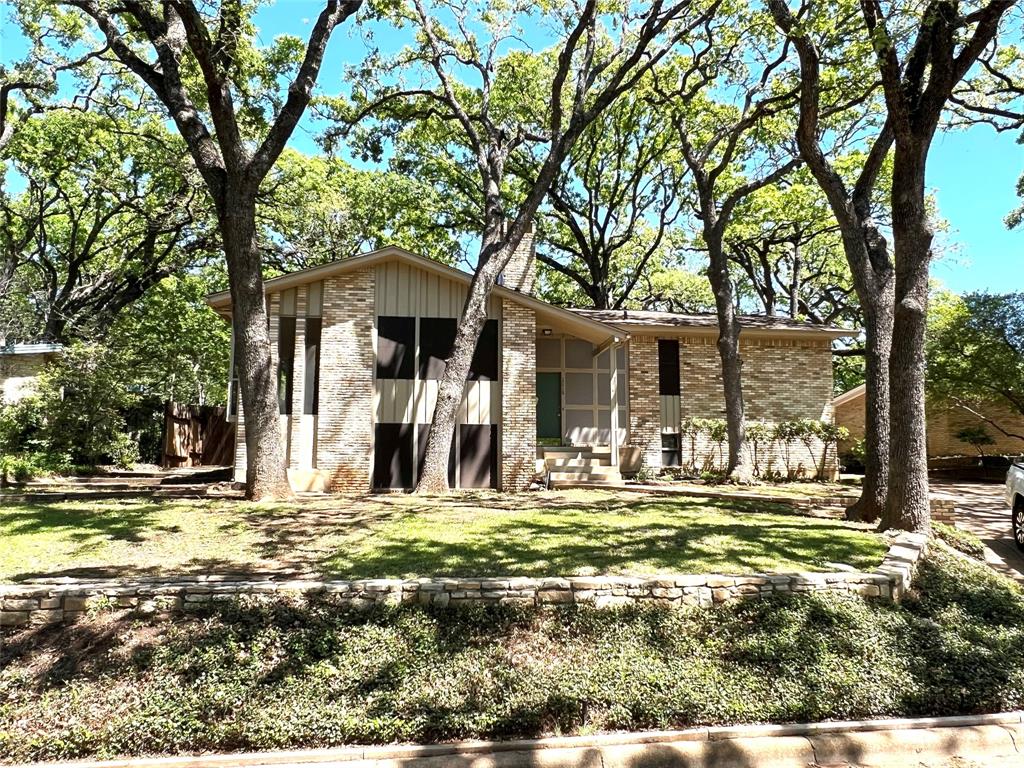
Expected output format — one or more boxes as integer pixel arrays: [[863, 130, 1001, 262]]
[[0, 490, 885, 580]]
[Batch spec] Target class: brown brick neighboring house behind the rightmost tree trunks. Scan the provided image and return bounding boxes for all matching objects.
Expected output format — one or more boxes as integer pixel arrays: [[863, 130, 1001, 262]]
[[833, 384, 1024, 458]]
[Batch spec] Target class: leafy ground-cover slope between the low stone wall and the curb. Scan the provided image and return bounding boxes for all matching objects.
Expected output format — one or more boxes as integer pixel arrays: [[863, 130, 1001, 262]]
[[0, 549, 1024, 762]]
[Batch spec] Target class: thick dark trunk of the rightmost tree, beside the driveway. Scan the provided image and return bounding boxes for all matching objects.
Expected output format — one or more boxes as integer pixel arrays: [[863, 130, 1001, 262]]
[[881, 150, 933, 530]]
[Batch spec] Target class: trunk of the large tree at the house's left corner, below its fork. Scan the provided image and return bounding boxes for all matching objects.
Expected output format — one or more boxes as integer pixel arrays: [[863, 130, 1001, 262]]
[[218, 193, 292, 501]]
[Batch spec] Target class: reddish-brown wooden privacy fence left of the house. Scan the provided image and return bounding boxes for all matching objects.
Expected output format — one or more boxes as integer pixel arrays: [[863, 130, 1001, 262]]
[[162, 402, 234, 468]]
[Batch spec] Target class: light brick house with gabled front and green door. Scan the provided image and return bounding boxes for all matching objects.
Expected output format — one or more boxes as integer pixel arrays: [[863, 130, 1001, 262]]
[[209, 228, 850, 492]]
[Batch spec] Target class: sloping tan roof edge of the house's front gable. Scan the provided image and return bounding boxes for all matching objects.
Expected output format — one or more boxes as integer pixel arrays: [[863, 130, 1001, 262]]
[[206, 246, 629, 343]]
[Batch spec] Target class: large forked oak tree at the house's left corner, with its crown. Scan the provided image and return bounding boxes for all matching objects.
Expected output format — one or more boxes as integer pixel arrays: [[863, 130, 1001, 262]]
[[18, 0, 361, 499]]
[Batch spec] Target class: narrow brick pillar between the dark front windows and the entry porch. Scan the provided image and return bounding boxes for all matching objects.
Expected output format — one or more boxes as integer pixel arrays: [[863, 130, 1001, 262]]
[[501, 299, 537, 490]]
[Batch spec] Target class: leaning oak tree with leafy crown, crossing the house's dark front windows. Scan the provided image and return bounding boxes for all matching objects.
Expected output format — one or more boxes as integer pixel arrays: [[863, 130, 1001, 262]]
[[350, 0, 718, 492]]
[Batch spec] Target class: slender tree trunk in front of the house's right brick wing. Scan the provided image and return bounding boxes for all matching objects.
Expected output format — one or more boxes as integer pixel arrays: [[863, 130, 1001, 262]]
[[705, 230, 754, 483]]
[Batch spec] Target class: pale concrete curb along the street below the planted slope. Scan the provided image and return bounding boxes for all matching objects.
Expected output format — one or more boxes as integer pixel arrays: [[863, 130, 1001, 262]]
[[12, 712, 1024, 768]]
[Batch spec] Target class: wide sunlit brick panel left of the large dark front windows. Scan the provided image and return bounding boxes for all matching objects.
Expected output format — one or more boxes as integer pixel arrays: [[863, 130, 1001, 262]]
[[316, 268, 375, 492]]
